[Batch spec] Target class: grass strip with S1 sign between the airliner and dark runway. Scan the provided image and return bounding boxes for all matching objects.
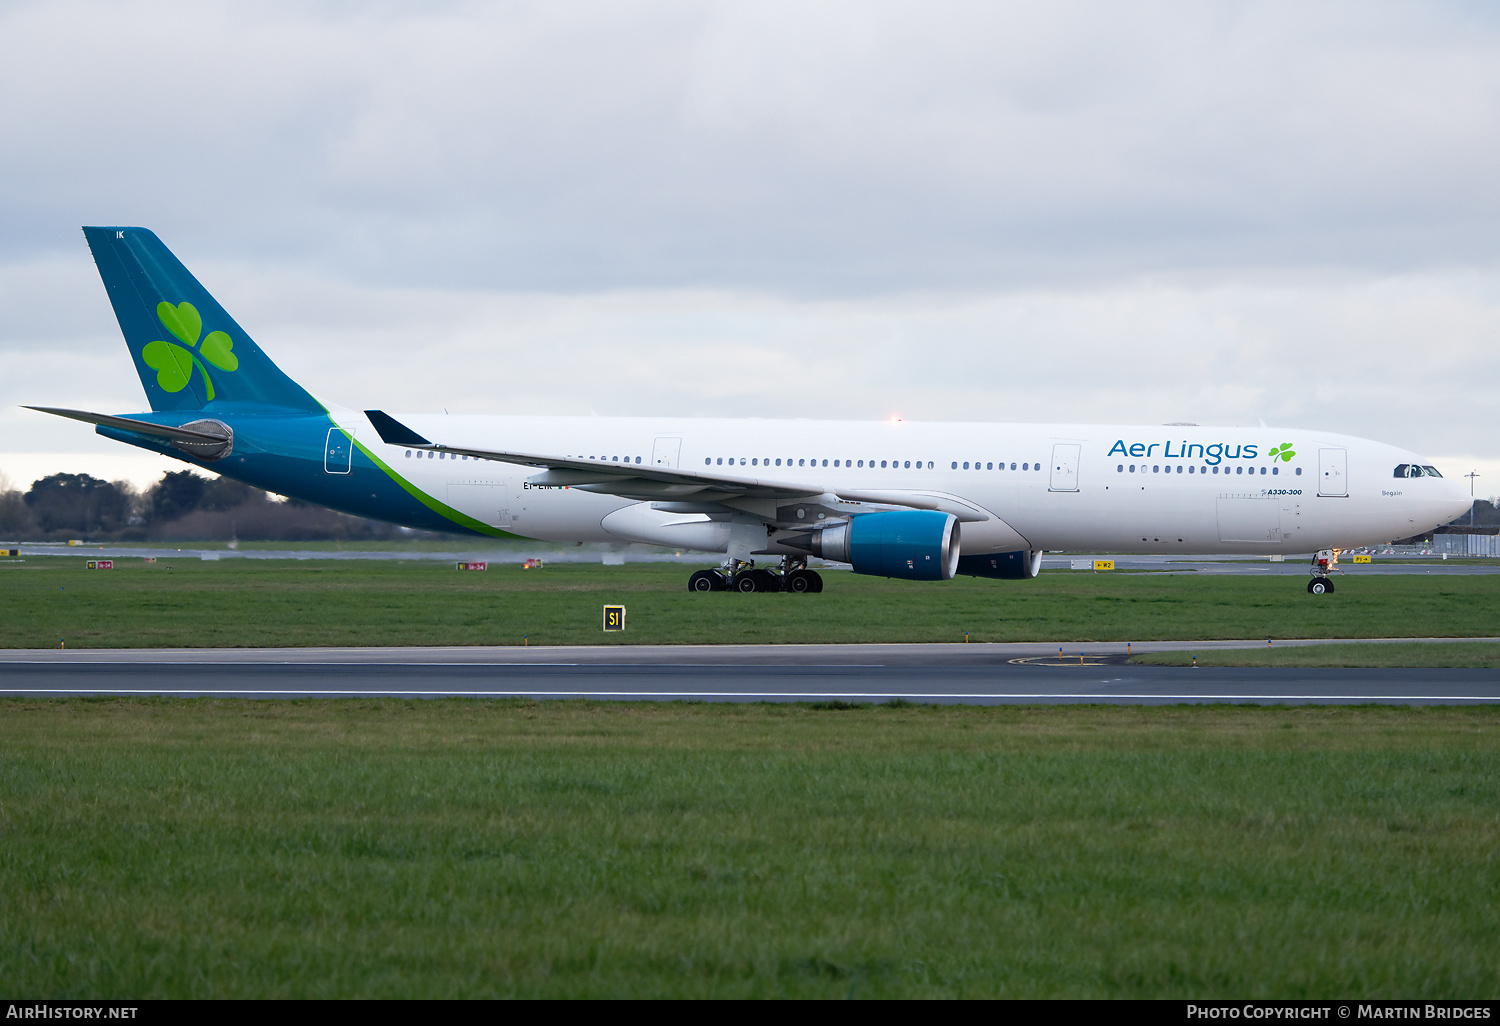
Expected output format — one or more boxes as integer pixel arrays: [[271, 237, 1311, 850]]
[[0, 557, 1500, 648]]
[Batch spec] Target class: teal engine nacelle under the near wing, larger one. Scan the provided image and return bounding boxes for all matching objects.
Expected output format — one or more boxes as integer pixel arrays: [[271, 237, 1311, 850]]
[[809, 510, 959, 581]]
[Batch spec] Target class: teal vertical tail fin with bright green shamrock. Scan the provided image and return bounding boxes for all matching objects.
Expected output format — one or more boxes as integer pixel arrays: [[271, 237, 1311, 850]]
[[84, 228, 323, 413]]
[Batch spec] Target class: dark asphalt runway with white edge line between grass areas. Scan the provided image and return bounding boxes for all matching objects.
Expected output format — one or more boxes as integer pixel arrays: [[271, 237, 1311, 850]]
[[0, 641, 1500, 705]]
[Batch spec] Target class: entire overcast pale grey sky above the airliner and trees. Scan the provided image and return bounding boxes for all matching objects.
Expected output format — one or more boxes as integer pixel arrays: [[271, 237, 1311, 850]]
[[0, 0, 1500, 495]]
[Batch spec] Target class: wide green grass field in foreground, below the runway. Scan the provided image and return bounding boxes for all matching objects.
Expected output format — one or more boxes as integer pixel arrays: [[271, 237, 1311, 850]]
[[0, 699, 1500, 999]]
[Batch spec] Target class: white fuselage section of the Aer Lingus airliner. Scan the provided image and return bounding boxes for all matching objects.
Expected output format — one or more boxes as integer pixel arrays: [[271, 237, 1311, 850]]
[[333, 410, 1470, 555]]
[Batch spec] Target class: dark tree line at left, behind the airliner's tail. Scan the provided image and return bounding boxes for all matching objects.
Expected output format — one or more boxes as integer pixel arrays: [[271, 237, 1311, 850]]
[[0, 471, 456, 542]]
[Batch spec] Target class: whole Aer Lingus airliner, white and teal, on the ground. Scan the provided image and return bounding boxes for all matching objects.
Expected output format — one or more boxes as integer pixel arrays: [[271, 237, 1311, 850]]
[[30, 227, 1470, 594]]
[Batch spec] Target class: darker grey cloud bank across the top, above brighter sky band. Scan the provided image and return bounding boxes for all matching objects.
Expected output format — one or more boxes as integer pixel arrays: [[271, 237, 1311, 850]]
[[0, 3, 1500, 286]]
